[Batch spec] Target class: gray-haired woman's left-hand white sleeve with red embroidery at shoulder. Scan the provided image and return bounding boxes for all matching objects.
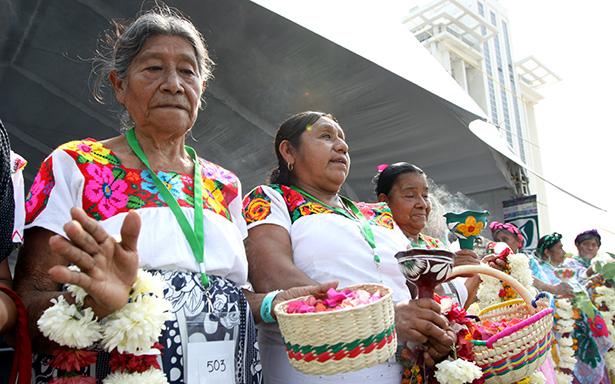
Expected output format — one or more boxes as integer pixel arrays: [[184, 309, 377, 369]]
[[25, 149, 84, 237]]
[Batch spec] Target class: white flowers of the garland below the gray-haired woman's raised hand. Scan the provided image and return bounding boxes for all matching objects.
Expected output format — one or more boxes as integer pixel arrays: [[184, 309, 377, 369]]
[[37, 266, 171, 384]]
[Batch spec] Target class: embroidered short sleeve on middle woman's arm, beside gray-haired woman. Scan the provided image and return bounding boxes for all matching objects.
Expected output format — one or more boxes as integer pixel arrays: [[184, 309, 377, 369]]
[[243, 185, 292, 233]]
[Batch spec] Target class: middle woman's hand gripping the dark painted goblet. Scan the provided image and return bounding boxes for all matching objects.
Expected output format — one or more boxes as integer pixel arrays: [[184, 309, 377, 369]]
[[395, 299, 452, 344]]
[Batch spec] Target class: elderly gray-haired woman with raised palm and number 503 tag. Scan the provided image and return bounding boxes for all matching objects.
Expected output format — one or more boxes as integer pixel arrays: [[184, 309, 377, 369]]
[[15, 7, 333, 383]]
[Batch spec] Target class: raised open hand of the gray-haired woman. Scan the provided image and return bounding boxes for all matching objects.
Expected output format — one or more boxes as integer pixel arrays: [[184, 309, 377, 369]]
[[49, 208, 141, 318]]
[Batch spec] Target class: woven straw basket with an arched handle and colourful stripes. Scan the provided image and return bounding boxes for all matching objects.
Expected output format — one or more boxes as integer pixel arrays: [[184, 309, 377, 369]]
[[451, 265, 553, 384]]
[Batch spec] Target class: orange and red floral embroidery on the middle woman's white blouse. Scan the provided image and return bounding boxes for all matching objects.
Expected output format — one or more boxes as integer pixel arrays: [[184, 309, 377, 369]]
[[243, 184, 393, 229]]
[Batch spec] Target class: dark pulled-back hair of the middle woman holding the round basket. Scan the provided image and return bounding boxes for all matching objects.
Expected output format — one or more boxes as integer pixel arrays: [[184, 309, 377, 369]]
[[268, 111, 337, 185]]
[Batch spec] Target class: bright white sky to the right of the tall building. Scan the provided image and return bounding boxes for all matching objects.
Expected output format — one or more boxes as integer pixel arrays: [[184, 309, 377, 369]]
[[387, 0, 615, 252]]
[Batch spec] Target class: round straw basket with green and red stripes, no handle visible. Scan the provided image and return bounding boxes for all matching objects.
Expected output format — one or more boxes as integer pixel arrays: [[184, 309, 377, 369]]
[[275, 284, 397, 375]]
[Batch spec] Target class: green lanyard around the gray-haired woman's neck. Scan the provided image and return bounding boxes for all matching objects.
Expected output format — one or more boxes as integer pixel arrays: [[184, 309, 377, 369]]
[[126, 128, 209, 287]]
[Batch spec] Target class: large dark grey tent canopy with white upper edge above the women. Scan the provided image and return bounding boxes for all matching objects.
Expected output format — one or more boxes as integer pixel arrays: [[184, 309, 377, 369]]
[[0, 0, 511, 204]]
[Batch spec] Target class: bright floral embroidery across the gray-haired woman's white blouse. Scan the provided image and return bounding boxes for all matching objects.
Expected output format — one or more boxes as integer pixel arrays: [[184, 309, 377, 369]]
[[26, 139, 239, 223]]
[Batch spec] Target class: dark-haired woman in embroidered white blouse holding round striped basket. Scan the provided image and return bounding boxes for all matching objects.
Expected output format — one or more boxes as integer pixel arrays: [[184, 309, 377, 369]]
[[244, 112, 453, 384]]
